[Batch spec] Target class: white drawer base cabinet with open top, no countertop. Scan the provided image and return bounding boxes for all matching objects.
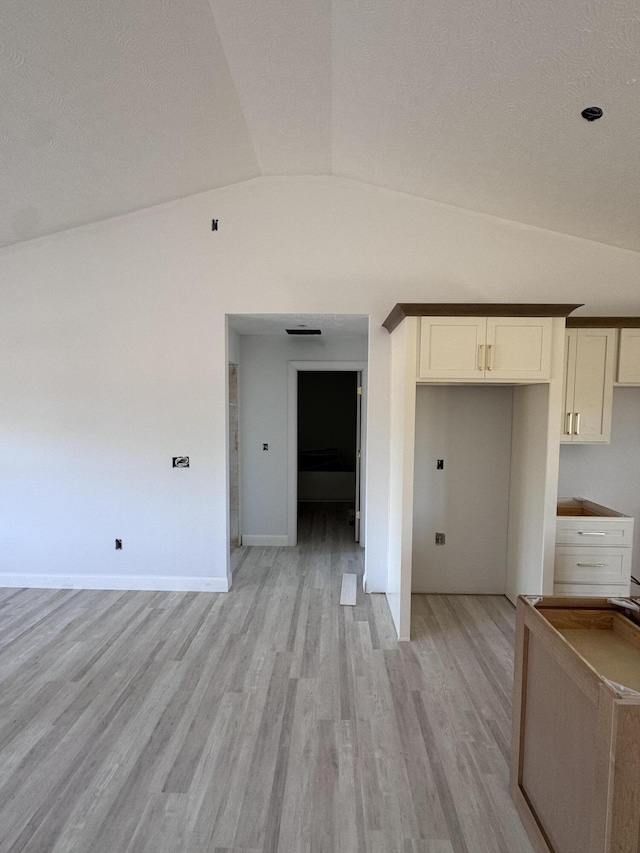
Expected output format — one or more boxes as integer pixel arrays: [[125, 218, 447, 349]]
[[553, 498, 634, 596]]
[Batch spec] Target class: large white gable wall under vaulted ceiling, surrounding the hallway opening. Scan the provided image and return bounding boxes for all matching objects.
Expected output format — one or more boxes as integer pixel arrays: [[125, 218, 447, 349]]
[[0, 177, 640, 590]]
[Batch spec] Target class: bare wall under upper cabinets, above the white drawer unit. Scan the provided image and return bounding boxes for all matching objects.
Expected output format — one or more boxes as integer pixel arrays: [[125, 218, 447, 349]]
[[558, 388, 640, 589]]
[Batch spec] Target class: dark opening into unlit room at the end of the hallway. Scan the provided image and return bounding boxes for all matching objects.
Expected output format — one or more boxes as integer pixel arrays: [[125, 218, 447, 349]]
[[297, 370, 362, 542]]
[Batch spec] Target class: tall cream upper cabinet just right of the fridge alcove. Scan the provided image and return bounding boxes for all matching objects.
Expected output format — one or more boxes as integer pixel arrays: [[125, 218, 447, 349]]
[[560, 328, 617, 444]]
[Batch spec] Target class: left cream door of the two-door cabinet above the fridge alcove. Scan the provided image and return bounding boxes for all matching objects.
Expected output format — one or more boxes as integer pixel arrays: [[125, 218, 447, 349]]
[[418, 317, 487, 379]]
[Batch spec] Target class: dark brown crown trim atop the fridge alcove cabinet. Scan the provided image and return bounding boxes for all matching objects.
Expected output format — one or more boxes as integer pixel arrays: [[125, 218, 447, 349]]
[[382, 302, 582, 332]]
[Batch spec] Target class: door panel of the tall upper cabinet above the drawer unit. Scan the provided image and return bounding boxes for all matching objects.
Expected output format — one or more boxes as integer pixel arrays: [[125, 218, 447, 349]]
[[573, 329, 616, 444]]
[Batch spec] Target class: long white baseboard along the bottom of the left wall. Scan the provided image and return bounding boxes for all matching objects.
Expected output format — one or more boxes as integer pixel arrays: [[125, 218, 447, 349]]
[[0, 574, 230, 592]]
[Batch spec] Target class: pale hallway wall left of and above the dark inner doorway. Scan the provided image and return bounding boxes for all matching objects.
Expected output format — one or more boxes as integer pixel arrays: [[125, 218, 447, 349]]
[[240, 335, 368, 541]]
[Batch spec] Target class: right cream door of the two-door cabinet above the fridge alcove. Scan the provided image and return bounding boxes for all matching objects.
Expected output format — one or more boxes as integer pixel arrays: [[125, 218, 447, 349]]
[[486, 317, 553, 381]]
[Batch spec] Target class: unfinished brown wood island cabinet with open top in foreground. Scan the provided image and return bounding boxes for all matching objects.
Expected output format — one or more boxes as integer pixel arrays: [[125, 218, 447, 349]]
[[511, 596, 640, 853]]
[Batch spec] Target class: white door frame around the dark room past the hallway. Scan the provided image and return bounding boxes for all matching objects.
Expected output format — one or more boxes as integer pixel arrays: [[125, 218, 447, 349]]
[[287, 361, 367, 547]]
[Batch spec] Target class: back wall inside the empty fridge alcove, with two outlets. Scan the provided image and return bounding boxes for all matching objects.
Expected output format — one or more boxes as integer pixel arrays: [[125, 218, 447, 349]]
[[412, 385, 513, 595]]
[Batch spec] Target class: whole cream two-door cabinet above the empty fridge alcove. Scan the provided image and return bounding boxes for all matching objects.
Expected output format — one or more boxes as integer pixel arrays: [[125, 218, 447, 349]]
[[418, 316, 553, 382]]
